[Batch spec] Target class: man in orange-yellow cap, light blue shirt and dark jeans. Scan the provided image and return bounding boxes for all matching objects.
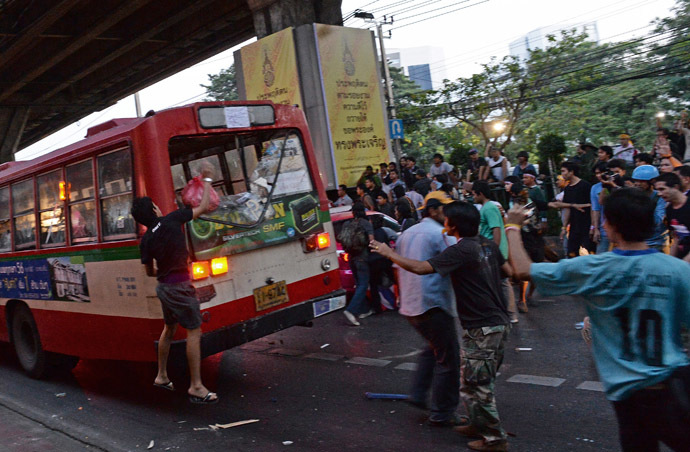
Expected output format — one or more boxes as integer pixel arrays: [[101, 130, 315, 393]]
[[396, 191, 460, 426]]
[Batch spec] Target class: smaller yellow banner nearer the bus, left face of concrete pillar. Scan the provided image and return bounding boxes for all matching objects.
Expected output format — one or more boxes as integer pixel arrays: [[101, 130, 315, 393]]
[[240, 28, 302, 105]]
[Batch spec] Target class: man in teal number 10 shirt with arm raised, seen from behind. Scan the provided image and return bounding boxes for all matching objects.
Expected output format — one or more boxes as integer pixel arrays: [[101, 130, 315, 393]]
[[506, 188, 690, 452]]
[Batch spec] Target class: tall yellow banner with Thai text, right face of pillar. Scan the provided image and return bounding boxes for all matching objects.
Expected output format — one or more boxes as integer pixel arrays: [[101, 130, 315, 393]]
[[316, 24, 389, 186]]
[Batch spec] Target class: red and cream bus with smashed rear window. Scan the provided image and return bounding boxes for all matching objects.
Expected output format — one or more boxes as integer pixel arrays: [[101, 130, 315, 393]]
[[0, 101, 345, 377]]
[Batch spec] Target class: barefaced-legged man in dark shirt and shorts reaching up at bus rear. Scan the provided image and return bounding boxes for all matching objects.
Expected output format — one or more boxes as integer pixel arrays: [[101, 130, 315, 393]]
[[132, 173, 218, 404]]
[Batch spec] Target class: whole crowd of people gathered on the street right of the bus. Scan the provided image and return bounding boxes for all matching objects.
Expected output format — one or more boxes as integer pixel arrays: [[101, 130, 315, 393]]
[[334, 115, 690, 451]]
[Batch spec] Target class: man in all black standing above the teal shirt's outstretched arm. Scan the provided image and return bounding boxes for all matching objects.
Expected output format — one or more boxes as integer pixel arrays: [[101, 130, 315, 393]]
[[561, 162, 592, 257]]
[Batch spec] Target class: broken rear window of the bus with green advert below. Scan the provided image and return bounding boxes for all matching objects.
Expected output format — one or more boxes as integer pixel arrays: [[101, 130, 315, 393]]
[[170, 130, 320, 256]]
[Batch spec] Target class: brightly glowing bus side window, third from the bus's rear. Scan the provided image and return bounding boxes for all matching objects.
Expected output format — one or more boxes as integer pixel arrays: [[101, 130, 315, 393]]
[[36, 170, 65, 247]]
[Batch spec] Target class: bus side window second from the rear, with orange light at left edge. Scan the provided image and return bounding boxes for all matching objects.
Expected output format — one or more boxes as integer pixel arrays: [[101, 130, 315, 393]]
[[66, 160, 98, 243]]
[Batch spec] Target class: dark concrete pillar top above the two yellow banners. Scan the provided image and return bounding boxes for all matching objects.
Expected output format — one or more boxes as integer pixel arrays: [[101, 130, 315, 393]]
[[247, 0, 343, 39]]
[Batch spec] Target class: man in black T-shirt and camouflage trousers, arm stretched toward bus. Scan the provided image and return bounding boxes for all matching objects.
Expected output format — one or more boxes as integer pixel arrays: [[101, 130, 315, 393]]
[[370, 201, 511, 451]]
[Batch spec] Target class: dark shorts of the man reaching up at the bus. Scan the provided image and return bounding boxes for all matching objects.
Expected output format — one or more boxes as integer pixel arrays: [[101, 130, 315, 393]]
[[156, 281, 201, 330]]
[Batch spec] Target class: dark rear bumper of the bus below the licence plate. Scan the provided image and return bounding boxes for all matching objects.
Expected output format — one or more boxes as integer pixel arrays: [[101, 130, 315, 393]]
[[165, 289, 346, 362]]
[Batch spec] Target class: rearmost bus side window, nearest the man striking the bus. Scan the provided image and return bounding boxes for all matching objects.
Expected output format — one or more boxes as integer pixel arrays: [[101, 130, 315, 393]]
[[98, 148, 136, 240]]
